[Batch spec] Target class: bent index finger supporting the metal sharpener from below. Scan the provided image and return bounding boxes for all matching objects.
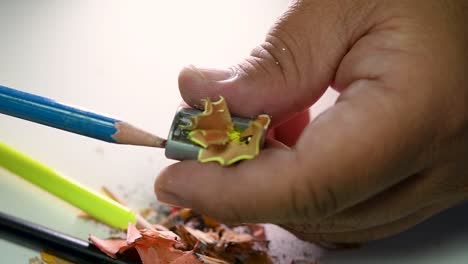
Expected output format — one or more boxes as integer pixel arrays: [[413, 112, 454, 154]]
[[155, 81, 424, 223]]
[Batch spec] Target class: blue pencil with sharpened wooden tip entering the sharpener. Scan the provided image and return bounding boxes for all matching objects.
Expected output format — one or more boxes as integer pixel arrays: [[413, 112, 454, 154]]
[[0, 85, 166, 148]]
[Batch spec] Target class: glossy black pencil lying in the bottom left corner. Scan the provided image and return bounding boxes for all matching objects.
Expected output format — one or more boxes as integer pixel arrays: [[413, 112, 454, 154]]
[[0, 212, 139, 264]]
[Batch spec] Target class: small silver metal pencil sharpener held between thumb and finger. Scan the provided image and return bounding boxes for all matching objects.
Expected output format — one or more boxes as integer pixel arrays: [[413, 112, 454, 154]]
[[165, 107, 266, 160]]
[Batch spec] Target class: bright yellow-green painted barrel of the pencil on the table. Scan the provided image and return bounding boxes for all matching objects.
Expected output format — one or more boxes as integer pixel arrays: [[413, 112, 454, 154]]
[[0, 142, 136, 229]]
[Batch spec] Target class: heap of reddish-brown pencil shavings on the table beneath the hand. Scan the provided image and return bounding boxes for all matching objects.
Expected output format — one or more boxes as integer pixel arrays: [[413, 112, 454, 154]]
[[90, 209, 272, 264]]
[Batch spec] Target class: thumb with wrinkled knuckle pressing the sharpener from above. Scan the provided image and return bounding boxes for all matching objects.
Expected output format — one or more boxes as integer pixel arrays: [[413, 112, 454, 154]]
[[179, 1, 352, 123]]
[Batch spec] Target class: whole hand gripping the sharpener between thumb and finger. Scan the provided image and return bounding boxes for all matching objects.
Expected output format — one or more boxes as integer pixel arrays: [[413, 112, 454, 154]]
[[155, 0, 468, 242]]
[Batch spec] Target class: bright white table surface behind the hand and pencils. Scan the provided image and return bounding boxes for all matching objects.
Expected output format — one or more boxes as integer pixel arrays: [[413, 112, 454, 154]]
[[0, 0, 468, 264]]
